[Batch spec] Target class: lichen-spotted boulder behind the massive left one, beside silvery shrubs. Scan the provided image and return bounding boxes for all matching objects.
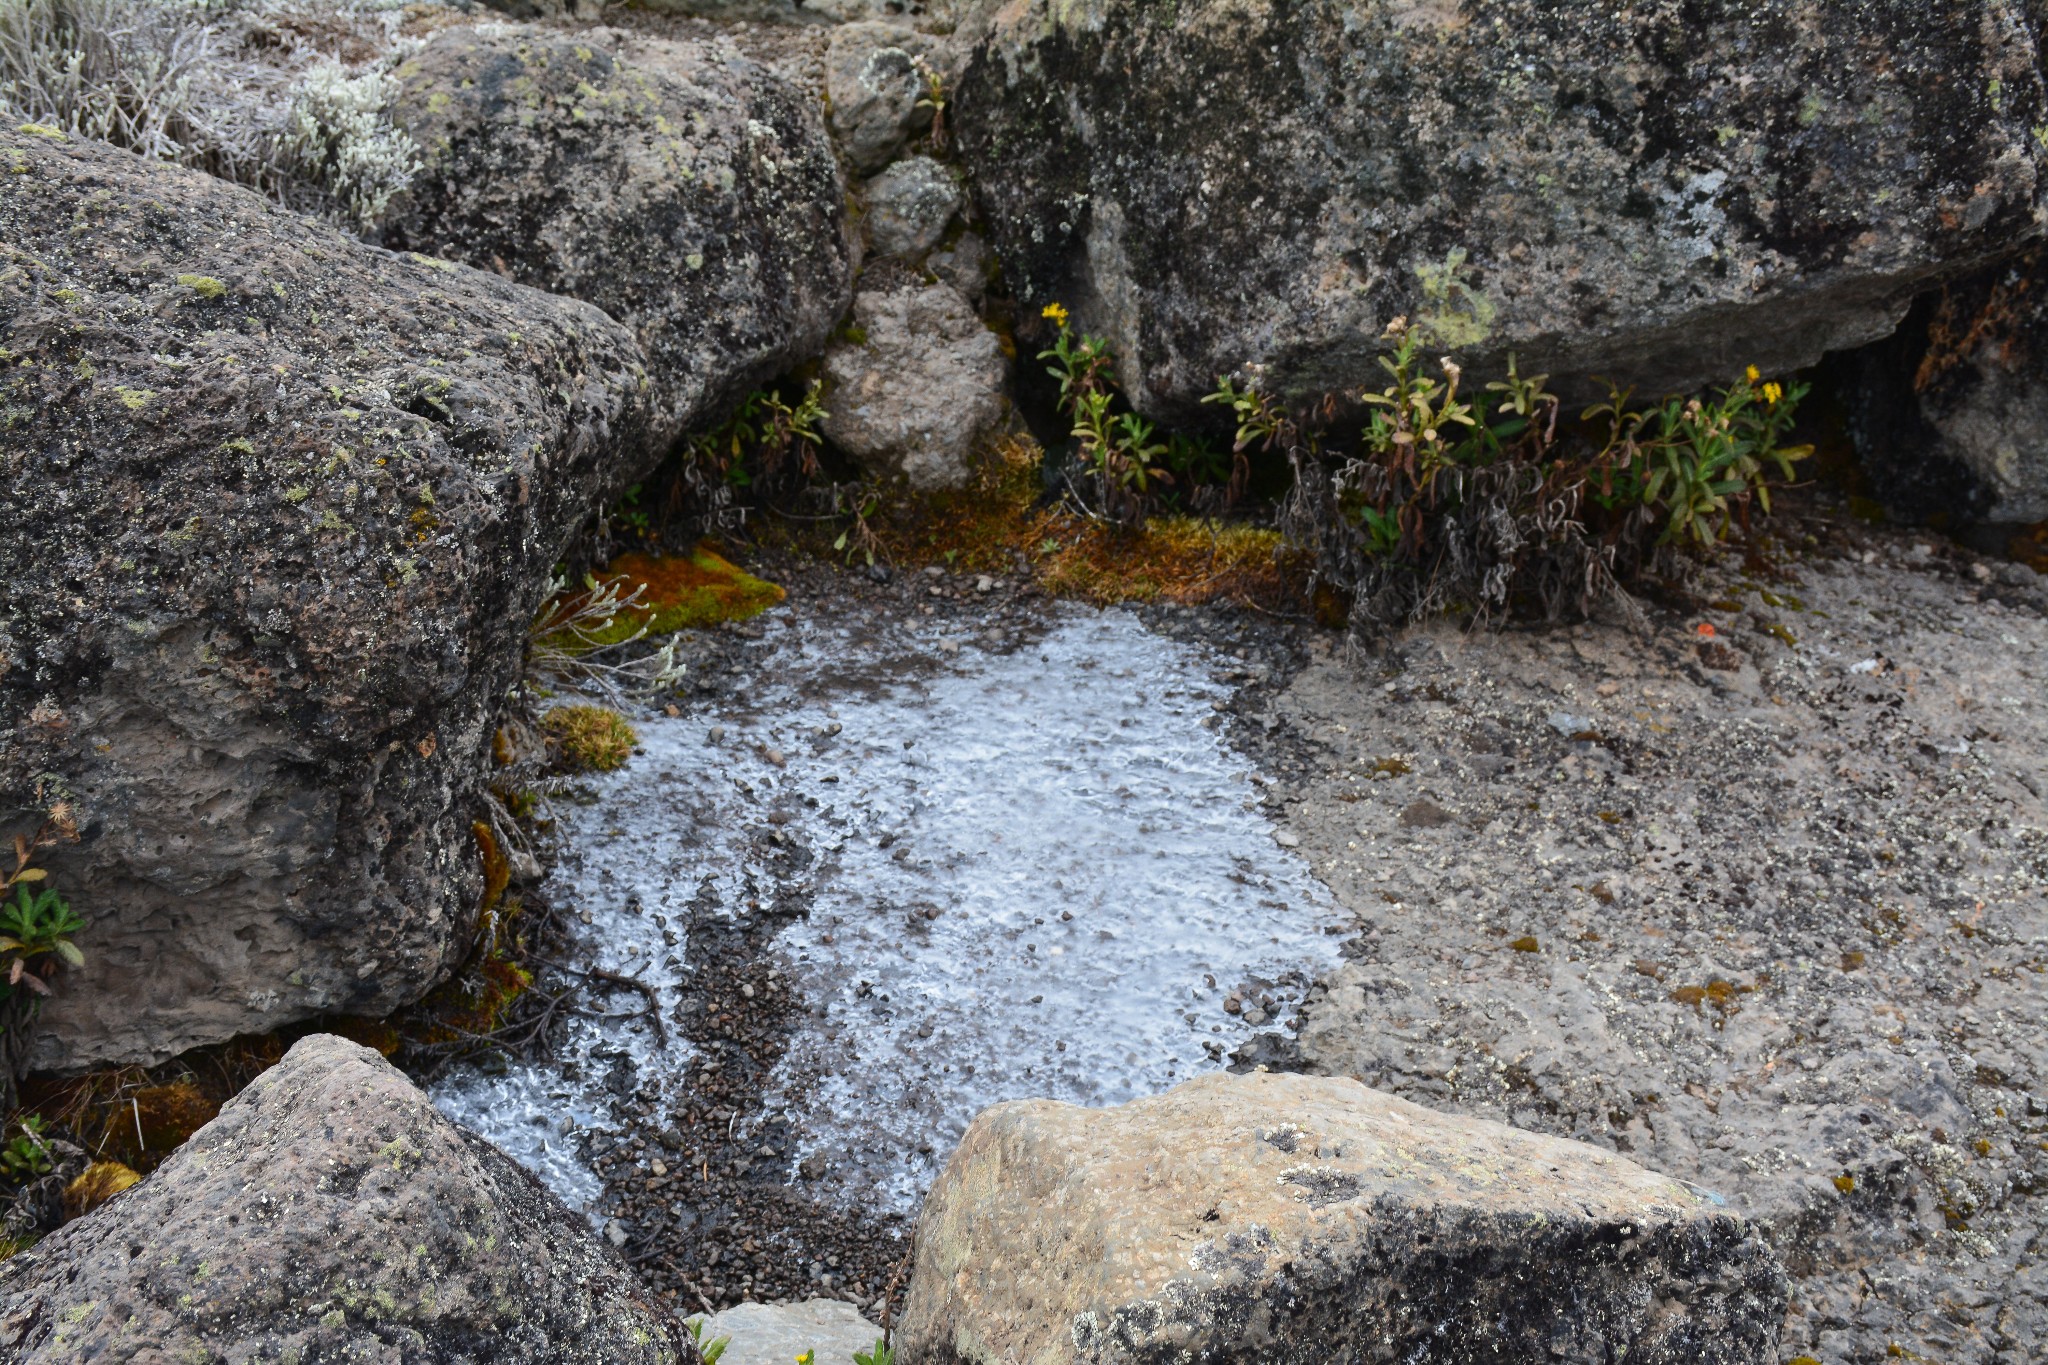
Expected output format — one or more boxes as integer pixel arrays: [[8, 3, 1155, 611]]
[[383, 29, 852, 438]]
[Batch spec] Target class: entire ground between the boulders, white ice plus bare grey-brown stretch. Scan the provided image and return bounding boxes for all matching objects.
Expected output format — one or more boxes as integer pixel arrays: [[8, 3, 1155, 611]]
[[444, 514, 2048, 1365]]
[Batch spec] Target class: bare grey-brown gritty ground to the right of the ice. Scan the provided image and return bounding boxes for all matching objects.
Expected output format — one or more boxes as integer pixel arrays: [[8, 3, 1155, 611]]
[[1239, 518, 2048, 1365]]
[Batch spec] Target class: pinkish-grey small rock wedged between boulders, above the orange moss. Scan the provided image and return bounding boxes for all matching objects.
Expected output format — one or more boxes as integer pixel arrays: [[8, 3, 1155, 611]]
[[823, 284, 1008, 489]]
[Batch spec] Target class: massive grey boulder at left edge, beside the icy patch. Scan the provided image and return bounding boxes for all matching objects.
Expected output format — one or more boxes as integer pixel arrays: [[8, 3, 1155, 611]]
[[0, 129, 649, 1068]]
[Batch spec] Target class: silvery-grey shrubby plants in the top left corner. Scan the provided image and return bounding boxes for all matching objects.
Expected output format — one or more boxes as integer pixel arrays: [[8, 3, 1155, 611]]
[[0, 0, 418, 229]]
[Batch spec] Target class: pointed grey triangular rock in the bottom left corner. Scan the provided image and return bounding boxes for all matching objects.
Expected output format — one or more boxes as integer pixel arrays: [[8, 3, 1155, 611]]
[[0, 1033, 694, 1365]]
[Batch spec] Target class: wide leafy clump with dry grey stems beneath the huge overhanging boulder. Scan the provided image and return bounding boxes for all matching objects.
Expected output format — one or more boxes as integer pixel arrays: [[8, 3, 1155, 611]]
[[1206, 298, 1810, 626]]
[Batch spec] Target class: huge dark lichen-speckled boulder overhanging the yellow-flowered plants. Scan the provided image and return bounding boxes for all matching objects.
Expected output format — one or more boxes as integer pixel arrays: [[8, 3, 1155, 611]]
[[948, 0, 2048, 415]]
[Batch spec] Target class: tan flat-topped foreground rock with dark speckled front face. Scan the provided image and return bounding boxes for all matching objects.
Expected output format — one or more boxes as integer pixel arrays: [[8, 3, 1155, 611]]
[[897, 1072, 1786, 1365]]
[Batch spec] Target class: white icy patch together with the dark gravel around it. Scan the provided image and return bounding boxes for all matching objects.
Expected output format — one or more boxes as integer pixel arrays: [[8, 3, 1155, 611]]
[[436, 575, 1350, 1308]]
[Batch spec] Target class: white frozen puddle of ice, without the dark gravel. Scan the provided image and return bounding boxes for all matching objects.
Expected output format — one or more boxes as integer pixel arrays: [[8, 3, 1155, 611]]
[[436, 608, 1337, 1212]]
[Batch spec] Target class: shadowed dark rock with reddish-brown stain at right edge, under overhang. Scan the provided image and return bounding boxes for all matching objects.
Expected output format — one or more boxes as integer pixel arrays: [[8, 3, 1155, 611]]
[[1841, 250, 2048, 528]]
